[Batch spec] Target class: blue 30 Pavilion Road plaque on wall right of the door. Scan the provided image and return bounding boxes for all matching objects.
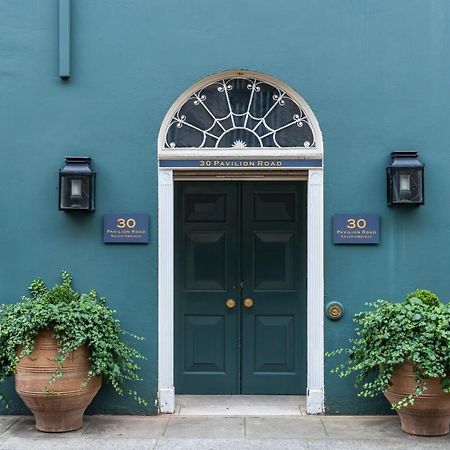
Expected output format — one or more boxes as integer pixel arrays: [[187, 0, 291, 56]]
[[333, 213, 380, 245]]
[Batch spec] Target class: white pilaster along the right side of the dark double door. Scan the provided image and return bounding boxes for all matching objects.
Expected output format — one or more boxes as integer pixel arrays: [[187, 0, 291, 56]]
[[307, 170, 324, 414]]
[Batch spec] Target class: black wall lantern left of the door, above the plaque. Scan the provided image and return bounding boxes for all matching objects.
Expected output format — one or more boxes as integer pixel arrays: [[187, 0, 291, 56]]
[[59, 156, 95, 211]]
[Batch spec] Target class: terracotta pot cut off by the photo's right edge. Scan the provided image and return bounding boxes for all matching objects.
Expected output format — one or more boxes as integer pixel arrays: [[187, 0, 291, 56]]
[[384, 362, 450, 436]]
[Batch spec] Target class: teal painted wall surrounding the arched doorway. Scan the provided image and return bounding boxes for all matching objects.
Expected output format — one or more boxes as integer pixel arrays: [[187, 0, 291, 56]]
[[0, 0, 450, 413]]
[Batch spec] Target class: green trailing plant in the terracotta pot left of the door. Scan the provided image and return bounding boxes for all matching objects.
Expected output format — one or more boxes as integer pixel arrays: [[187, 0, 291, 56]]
[[0, 270, 147, 405]]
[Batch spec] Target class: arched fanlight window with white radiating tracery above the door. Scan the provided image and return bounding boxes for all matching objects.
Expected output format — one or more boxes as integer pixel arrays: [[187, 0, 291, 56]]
[[164, 77, 316, 150]]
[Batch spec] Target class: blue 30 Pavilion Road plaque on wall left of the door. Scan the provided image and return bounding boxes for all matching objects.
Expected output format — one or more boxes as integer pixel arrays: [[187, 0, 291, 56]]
[[103, 214, 149, 244]]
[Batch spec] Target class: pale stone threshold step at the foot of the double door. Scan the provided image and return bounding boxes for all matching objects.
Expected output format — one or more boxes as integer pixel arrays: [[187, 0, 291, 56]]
[[174, 395, 306, 417]]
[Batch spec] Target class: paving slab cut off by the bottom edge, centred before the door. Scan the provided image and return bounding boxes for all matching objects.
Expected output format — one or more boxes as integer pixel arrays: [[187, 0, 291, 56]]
[[156, 439, 308, 450]]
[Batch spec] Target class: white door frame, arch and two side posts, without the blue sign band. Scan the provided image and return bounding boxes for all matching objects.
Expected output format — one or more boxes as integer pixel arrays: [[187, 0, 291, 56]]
[[158, 71, 324, 414]]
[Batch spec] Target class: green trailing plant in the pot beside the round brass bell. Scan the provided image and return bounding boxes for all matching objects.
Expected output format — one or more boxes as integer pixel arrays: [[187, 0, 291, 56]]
[[327, 289, 450, 409]]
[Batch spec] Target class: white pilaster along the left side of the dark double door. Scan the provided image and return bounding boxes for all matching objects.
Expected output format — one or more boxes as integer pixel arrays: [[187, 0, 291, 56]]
[[158, 170, 175, 414]]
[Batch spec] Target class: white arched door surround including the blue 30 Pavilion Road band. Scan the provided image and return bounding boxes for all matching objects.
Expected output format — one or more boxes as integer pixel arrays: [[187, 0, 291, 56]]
[[158, 70, 324, 414]]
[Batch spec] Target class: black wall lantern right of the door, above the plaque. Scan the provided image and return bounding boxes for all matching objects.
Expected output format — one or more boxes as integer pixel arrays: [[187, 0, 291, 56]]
[[386, 151, 424, 206]]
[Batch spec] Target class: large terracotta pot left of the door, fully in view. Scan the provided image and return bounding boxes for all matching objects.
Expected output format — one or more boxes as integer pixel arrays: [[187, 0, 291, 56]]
[[15, 331, 102, 432]]
